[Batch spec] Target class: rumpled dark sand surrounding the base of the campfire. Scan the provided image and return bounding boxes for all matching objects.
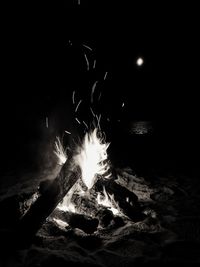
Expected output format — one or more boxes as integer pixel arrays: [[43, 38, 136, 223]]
[[0, 168, 200, 267]]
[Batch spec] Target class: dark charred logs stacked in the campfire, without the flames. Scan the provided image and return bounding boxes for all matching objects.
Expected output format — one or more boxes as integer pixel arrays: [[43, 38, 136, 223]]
[[15, 161, 144, 249]]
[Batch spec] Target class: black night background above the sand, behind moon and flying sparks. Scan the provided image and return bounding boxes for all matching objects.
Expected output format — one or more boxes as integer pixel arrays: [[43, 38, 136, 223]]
[[0, 0, 199, 177]]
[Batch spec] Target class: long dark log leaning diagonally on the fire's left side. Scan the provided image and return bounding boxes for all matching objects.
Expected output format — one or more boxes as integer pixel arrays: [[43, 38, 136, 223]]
[[16, 161, 80, 246]]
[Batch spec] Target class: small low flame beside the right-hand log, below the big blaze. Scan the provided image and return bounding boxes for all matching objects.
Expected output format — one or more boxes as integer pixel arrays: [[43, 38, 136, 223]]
[[97, 187, 120, 215]]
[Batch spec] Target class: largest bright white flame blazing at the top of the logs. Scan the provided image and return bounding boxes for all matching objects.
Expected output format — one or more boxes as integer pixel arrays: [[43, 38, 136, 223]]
[[75, 128, 110, 189]]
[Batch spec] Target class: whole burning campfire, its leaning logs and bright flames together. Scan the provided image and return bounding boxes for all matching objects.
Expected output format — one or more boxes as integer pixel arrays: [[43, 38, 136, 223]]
[[16, 128, 144, 248]]
